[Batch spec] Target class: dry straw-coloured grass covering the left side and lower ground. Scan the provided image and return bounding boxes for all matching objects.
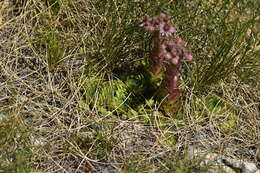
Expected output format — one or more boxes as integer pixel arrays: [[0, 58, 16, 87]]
[[0, 0, 260, 173]]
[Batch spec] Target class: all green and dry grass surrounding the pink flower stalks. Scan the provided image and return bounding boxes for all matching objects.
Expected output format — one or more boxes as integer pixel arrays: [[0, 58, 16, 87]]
[[0, 0, 260, 173]]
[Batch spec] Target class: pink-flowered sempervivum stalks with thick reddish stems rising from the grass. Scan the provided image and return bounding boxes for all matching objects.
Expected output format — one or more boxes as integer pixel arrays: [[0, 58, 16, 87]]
[[140, 13, 193, 103]]
